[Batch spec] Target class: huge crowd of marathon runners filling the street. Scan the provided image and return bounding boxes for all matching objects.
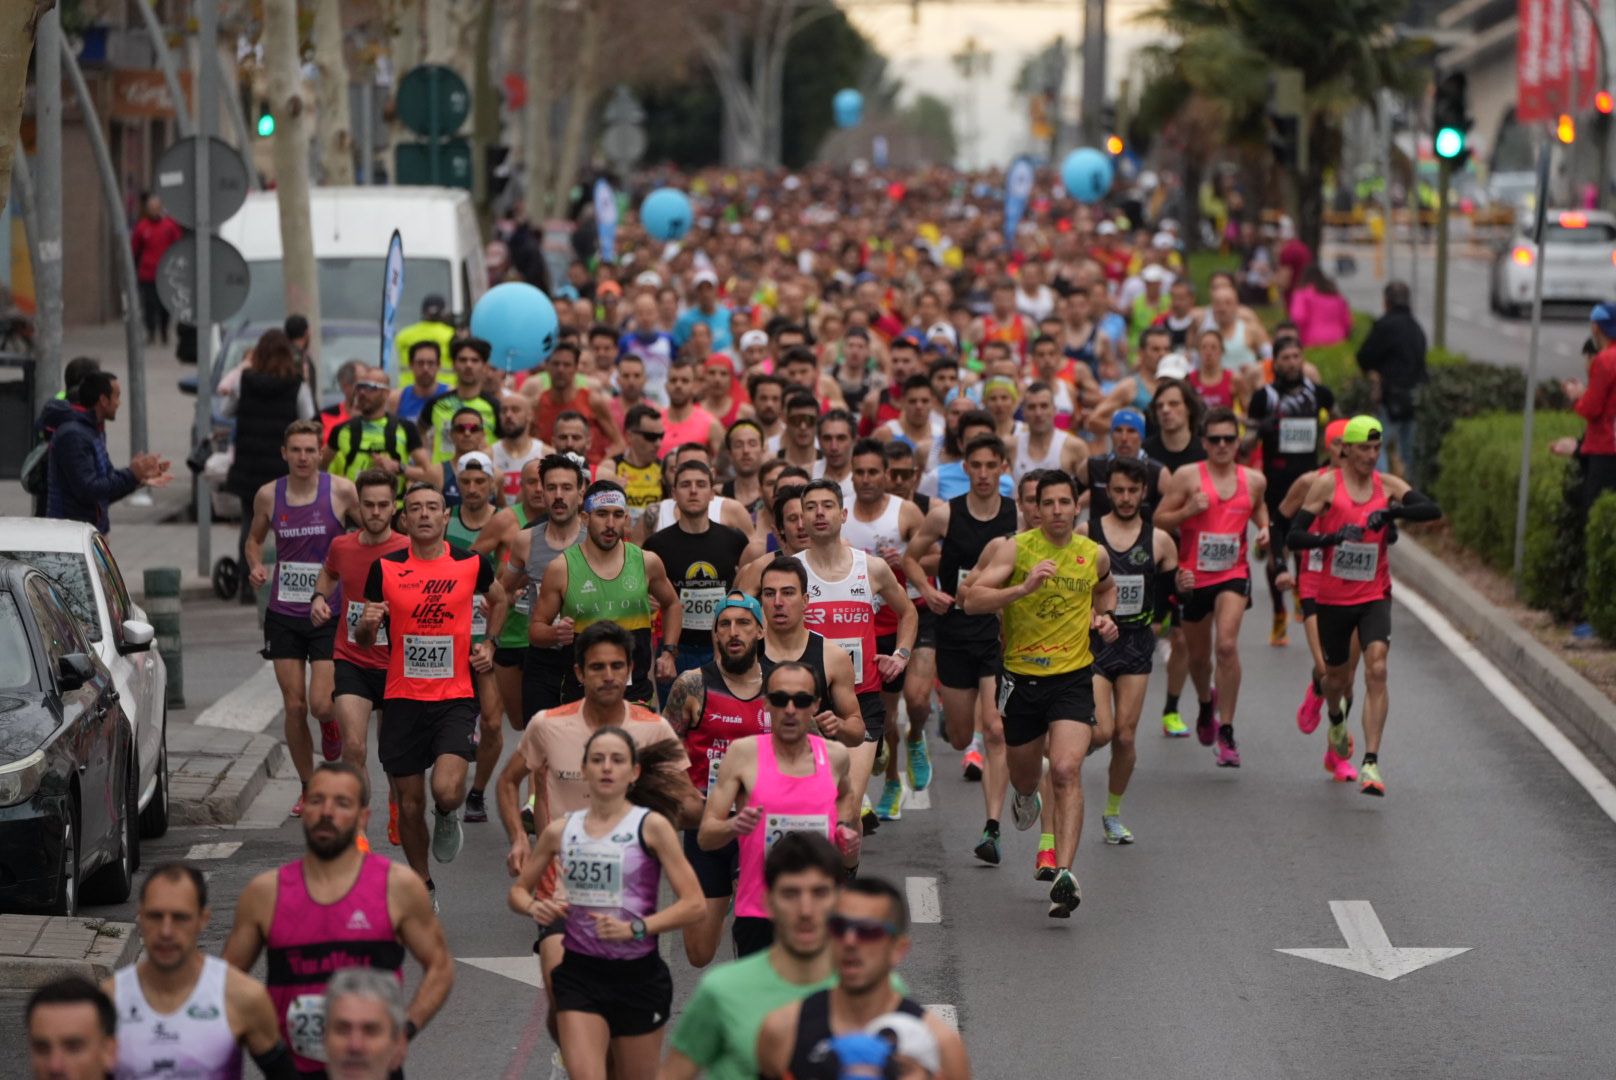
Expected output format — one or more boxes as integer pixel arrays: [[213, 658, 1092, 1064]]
[[29, 162, 1438, 1080]]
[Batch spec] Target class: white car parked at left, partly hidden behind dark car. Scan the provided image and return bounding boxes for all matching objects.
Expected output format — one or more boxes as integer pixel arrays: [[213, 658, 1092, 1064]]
[[0, 517, 168, 837]]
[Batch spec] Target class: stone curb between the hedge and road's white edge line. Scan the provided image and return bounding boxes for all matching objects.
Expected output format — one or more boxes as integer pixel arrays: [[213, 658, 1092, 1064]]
[[1395, 542, 1616, 760]]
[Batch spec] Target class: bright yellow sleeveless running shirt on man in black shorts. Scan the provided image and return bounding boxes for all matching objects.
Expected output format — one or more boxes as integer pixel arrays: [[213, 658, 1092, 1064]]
[[1004, 529, 1099, 676]]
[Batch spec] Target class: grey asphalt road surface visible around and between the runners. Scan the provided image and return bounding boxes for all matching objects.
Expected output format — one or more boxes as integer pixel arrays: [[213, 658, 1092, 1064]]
[[0, 585, 1616, 1080]]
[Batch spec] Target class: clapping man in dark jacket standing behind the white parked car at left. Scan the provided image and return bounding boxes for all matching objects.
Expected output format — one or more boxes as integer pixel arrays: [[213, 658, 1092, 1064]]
[[45, 372, 173, 532]]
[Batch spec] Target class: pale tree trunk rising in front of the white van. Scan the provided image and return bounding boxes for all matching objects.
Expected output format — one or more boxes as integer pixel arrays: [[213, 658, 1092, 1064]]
[[263, 0, 320, 345]]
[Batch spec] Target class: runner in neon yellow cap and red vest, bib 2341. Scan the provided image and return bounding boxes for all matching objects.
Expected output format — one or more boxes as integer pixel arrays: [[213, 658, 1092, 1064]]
[[1290, 416, 1441, 795]]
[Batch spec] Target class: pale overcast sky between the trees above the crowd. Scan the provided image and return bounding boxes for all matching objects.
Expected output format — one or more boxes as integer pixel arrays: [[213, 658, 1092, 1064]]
[[842, 0, 1159, 165]]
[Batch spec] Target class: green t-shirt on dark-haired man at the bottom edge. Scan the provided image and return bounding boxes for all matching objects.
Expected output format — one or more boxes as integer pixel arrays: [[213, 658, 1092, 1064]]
[[659, 949, 908, 1080]]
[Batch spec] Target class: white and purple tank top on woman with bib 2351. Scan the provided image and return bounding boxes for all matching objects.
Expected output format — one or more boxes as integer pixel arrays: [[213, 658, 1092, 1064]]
[[561, 807, 663, 960]]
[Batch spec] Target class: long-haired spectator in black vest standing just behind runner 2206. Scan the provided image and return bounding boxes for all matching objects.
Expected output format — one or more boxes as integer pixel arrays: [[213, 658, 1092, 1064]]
[[223, 330, 314, 603]]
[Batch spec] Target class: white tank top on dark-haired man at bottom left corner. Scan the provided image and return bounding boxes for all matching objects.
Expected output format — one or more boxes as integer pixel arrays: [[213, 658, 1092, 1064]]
[[113, 956, 241, 1080]]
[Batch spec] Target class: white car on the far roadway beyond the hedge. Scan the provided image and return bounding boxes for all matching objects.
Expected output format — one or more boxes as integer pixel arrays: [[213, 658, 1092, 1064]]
[[1488, 210, 1616, 315]]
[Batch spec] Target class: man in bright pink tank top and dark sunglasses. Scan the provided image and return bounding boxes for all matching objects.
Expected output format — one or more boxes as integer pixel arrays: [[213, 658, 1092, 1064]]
[[696, 660, 860, 957]]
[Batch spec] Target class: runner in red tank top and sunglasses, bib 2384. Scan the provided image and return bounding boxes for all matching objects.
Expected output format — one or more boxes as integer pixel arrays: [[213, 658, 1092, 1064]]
[[1155, 409, 1269, 768]]
